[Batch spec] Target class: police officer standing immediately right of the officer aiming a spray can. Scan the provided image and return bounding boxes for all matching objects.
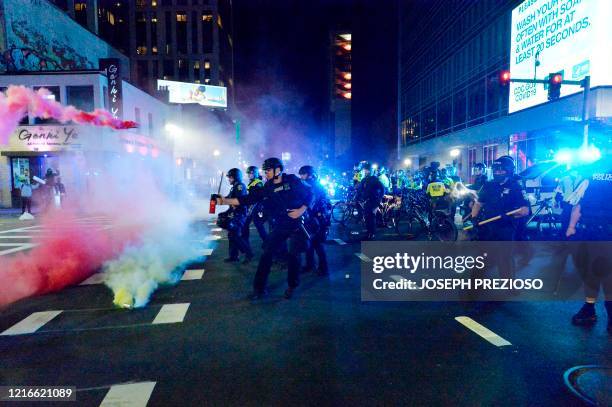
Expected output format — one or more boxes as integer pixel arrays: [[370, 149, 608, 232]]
[[299, 165, 331, 276]]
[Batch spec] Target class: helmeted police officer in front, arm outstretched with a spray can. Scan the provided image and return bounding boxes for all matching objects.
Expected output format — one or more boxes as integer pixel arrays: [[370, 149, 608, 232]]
[[217, 157, 313, 300]]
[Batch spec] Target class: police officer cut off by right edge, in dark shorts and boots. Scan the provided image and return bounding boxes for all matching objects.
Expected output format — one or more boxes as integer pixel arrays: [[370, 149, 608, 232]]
[[565, 156, 612, 334]]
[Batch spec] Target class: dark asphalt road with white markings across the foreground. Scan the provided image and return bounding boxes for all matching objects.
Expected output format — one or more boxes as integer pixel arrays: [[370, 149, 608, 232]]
[[0, 219, 612, 406]]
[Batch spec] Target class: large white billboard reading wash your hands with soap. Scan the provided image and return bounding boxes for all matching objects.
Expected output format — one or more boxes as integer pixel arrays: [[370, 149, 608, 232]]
[[508, 0, 612, 113]]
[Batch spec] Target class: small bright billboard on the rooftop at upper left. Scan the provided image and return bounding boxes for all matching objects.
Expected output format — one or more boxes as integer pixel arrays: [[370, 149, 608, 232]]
[[157, 79, 227, 108]]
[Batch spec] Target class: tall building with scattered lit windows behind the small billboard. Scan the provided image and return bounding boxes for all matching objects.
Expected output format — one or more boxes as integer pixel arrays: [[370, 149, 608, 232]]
[[47, 0, 234, 106]]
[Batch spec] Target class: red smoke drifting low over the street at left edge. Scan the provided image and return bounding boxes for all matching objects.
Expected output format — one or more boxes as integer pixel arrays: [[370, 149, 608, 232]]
[[0, 210, 139, 307]]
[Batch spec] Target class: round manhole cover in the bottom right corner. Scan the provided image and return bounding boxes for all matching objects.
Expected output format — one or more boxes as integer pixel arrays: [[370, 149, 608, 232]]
[[563, 365, 612, 406]]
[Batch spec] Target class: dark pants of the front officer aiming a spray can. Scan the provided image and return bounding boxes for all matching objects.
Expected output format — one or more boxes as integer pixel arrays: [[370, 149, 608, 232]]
[[253, 223, 307, 292]]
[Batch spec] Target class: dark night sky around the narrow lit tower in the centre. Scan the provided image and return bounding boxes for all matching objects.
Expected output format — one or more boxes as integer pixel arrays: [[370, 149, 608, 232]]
[[234, 0, 397, 167]]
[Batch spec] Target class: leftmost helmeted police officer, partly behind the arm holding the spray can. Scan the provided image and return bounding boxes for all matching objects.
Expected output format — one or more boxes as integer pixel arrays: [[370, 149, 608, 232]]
[[219, 168, 253, 263]]
